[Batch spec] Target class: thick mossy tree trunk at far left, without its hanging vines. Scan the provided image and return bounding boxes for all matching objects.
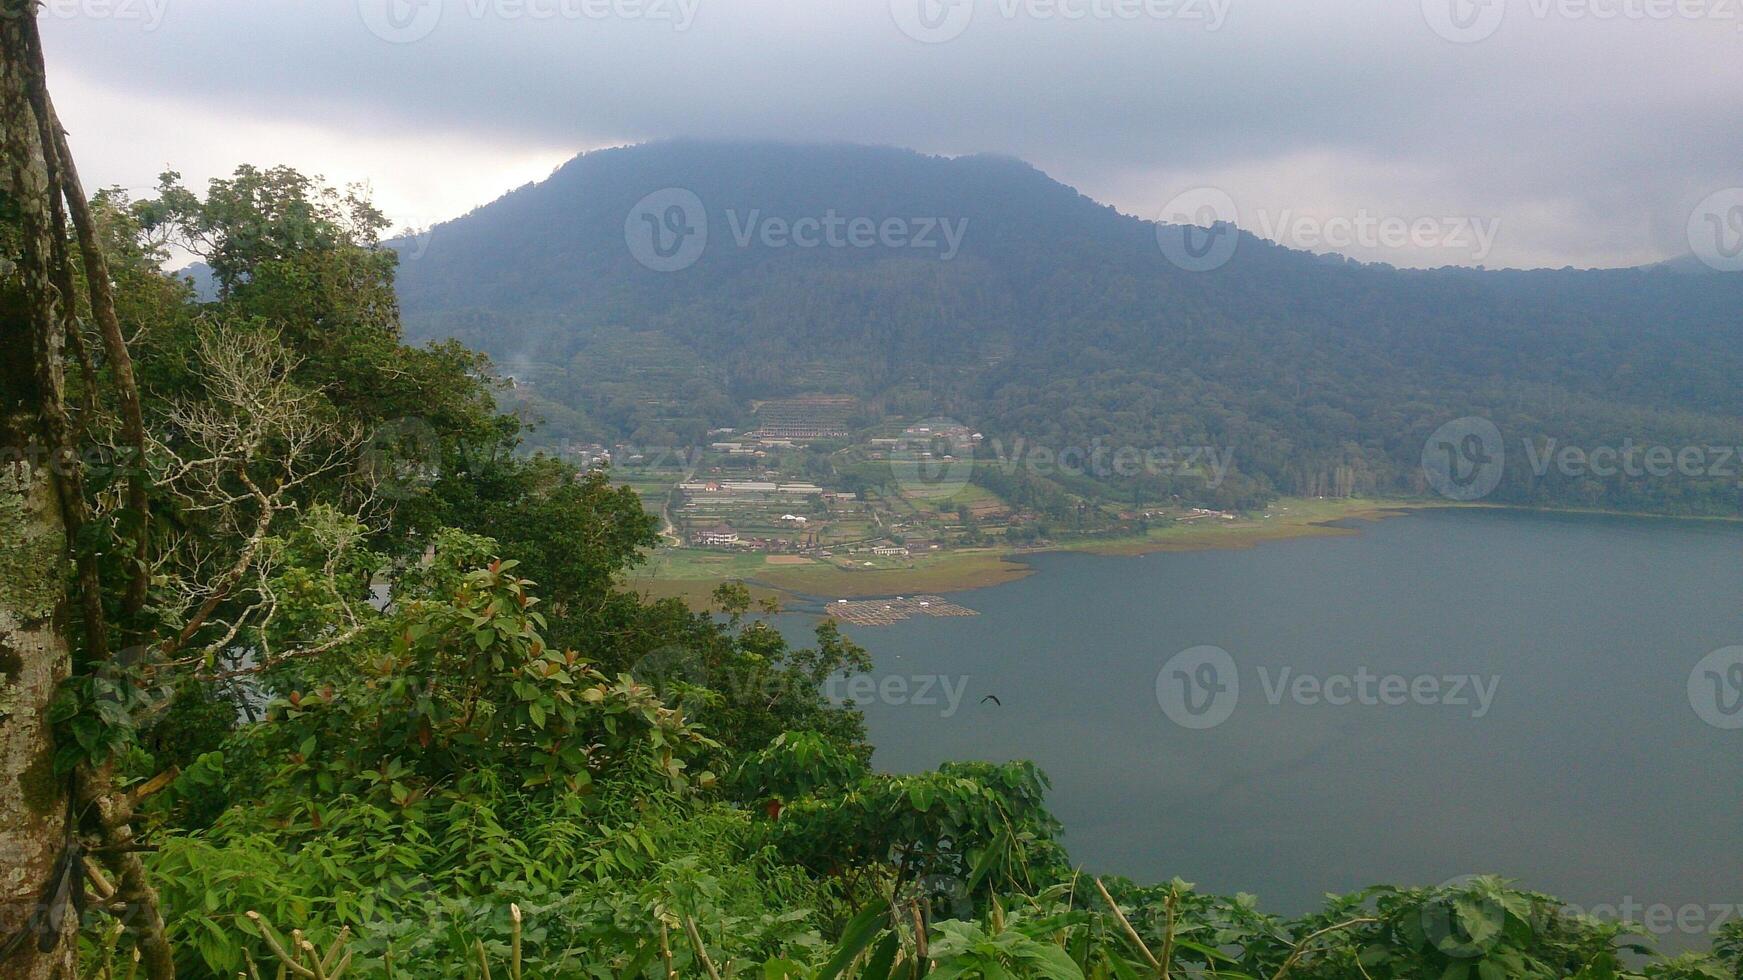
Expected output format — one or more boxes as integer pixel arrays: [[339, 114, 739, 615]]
[[0, 0, 78, 980]]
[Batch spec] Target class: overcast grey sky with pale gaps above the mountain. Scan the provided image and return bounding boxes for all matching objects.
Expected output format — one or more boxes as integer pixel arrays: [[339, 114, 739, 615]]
[[44, 0, 1743, 267]]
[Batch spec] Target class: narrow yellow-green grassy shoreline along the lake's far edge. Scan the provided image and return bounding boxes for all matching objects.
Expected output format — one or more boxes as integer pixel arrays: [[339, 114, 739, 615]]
[[622, 497, 1743, 609]]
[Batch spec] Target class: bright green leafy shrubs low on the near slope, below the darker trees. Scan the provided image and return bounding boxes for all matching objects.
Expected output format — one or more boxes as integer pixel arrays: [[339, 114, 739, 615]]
[[126, 558, 1738, 980]]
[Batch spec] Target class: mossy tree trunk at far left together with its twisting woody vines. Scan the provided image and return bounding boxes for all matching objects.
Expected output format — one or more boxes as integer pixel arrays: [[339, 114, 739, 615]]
[[0, 7, 176, 980]]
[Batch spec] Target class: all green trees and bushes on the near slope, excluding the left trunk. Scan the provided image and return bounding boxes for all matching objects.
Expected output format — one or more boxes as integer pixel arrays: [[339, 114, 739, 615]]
[[23, 162, 1743, 980]]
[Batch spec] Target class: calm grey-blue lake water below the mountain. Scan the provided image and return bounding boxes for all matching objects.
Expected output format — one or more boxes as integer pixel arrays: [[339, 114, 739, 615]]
[[781, 511, 1743, 947]]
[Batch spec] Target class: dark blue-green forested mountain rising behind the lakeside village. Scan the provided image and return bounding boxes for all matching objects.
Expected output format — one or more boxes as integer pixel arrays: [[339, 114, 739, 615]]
[[399, 143, 1743, 513]]
